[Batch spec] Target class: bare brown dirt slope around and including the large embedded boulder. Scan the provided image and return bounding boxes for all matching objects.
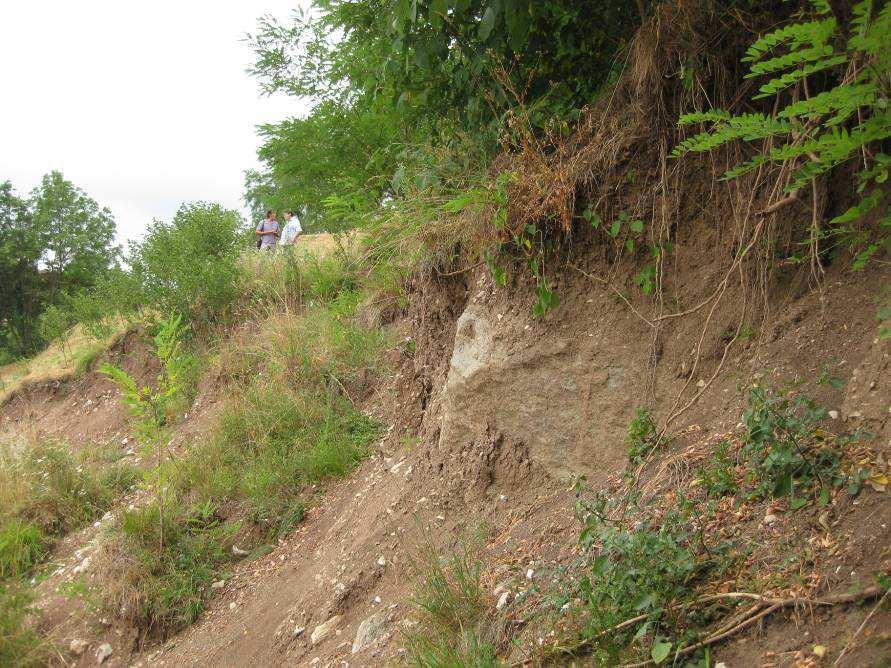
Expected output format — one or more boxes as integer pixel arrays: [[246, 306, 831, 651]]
[[106, 258, 891, 667]]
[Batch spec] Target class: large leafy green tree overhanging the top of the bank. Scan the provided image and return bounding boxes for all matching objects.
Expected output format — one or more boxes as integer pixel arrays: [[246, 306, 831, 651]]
[[246, 0, 652, 229]]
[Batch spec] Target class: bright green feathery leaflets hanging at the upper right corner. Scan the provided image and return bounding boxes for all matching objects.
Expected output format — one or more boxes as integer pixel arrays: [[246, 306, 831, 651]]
[[671, 0, 891, 270]]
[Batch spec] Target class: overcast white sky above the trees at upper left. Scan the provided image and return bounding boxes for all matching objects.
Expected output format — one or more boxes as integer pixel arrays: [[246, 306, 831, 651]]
[[0, 0, 308, 245]]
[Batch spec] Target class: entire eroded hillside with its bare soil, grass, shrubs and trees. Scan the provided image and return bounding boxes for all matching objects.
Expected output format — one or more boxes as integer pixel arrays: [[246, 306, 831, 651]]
[[0, 0, 891, 668]]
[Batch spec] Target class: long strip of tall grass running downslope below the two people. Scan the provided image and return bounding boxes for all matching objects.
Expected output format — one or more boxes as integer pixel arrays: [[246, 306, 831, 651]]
[[103, 253, 384, 636]]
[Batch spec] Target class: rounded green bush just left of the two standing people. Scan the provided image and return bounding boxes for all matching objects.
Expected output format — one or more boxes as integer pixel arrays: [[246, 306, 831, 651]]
[[129, 202, 245, 327]]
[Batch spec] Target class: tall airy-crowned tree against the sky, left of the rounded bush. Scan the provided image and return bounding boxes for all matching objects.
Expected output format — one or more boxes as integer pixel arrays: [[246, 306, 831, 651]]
[[31, 171, 120, 303]]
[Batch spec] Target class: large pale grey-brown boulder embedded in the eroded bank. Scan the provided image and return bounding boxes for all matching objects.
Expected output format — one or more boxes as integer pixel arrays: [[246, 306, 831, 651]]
[[440, 301, 635, 478]]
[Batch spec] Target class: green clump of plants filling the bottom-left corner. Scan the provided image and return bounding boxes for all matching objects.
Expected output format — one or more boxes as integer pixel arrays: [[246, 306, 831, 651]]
[[0, 582, 50, 668]]
